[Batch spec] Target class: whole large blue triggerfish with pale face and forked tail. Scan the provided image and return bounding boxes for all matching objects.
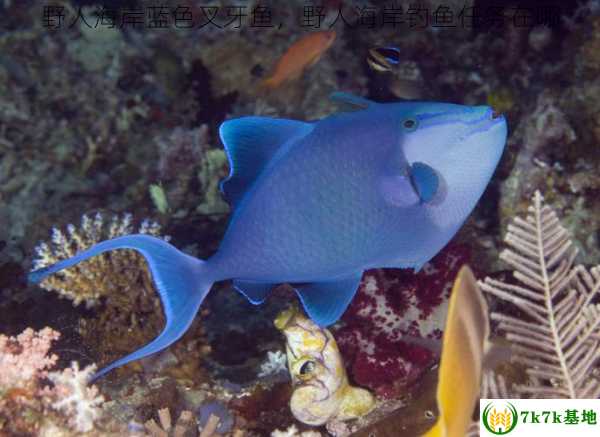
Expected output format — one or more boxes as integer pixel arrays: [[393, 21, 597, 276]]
[[30, 93, 507, 376]]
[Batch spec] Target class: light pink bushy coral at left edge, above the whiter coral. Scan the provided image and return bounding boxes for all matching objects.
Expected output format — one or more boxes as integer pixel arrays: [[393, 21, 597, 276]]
[[0, 328, 60, 389]]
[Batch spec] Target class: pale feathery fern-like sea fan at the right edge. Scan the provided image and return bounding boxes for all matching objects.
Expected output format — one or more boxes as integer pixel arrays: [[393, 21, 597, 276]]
[[480, 192, 600, 398]]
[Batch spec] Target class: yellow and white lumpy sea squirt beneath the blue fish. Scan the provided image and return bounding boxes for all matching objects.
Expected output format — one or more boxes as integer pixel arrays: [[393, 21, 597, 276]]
[[275, 306, 375, 425]]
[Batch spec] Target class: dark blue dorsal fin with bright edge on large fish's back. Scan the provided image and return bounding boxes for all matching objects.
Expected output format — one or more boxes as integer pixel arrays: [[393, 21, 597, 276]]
[[219, 117, 313, 207]]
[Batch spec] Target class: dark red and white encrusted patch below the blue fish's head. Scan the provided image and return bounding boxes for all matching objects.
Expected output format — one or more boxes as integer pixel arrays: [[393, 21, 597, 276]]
[[335, 244, 469, 397]]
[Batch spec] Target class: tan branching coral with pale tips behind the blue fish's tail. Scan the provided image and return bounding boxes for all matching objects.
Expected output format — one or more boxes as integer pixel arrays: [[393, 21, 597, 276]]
[[33, 213, 169, 307]]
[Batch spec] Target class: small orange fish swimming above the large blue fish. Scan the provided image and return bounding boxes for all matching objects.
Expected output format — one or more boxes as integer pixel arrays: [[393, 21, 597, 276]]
[[262, 30, 335, 89]]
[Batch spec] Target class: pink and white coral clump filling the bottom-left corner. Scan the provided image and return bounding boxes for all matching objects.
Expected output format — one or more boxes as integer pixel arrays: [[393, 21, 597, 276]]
[[0, 328, 124, 436]]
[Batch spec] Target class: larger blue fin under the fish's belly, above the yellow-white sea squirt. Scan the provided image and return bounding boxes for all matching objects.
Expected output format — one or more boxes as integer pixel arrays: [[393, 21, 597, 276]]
[[294, 272, 362, 327]]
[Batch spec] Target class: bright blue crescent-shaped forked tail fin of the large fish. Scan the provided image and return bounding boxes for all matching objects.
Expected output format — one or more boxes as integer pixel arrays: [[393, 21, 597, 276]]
[[28, 234, 212, 379]]
